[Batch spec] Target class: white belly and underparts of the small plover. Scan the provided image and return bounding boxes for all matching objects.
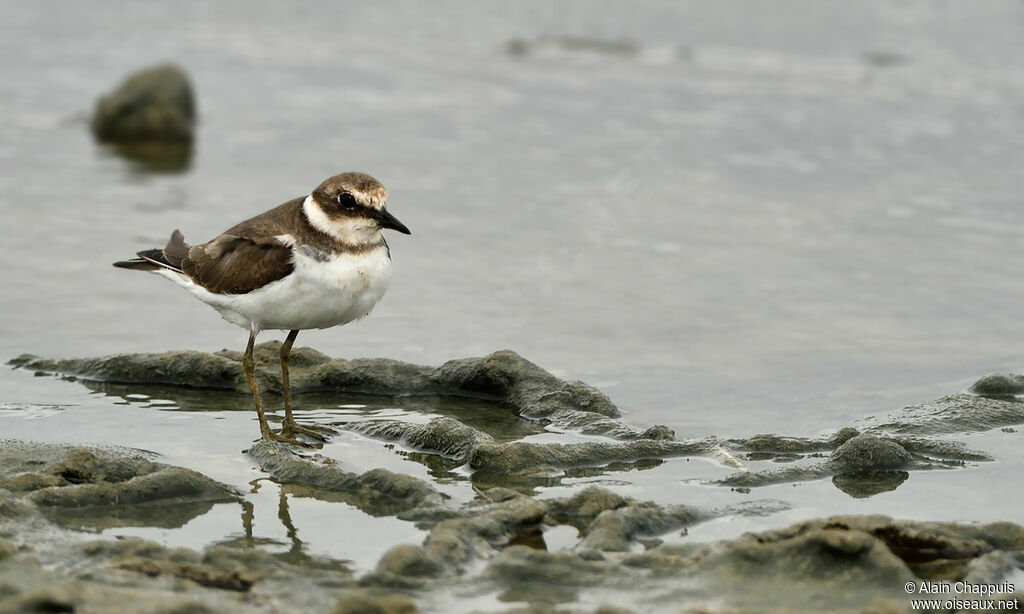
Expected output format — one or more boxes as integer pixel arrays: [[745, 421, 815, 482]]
[[158, 246, 391, 331]]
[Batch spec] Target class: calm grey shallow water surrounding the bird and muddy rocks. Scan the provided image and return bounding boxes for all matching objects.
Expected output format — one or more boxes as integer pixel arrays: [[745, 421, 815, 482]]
[[0, 0, 1024, 609]]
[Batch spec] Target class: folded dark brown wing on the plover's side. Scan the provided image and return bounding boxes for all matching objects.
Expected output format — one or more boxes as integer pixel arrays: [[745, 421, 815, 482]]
[[181, 234, 293, 294]]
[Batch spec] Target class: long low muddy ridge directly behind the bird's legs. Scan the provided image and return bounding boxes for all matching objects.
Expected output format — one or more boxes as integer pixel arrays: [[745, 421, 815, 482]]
[[10, 347, 672, 440]]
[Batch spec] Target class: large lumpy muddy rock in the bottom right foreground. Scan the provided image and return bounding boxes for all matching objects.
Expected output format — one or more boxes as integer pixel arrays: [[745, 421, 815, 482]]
[[485, 516, 1021, 613]]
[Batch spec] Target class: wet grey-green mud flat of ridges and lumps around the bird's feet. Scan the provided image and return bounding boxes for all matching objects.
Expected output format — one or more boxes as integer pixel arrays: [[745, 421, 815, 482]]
[[0, 343, 1024, 612]]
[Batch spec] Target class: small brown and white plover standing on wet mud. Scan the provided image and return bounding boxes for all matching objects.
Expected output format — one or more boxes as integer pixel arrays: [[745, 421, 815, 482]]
[[114, 173, 410, 443]]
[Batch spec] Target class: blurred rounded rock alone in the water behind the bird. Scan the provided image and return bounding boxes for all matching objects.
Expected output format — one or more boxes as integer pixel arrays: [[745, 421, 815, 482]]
[[91, 64, 196, 143]]
